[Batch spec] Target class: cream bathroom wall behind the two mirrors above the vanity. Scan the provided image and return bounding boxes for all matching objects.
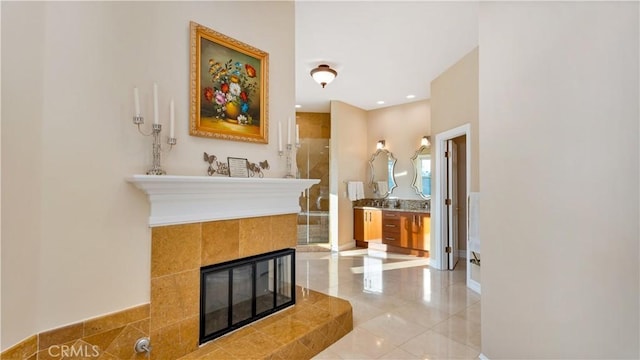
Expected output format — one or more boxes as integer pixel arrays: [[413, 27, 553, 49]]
[[365, 100, 431, 200]]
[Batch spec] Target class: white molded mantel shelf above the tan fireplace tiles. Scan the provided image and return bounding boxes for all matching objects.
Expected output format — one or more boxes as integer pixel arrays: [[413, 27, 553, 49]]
[[126, 175, 320, 227]]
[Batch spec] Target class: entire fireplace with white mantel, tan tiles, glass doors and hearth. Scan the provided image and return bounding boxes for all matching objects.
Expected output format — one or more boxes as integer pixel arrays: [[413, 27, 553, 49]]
[[127, 175, 352, 359]]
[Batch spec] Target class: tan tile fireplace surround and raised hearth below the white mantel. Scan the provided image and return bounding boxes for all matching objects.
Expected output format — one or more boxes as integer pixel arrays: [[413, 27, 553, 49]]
[[150, 218, 353, 359]]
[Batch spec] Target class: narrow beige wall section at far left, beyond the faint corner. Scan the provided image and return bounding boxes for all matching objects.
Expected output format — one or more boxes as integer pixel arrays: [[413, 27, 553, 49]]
[[0, 2, 45, 350]]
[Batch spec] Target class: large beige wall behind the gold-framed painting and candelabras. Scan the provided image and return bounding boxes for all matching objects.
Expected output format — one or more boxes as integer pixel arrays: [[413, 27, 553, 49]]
[[1, 2, 295, 349]]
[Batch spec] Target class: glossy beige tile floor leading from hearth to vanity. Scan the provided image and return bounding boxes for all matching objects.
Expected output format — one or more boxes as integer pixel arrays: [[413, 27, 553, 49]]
[[296, 249, 480, 360]]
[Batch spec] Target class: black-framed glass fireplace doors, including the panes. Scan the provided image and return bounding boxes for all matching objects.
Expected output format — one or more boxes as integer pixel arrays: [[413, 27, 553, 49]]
[[200, 249, 295, 343]]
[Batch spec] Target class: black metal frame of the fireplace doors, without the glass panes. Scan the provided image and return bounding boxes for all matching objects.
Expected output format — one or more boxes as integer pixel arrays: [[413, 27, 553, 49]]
[[199, 248, 296, 344]]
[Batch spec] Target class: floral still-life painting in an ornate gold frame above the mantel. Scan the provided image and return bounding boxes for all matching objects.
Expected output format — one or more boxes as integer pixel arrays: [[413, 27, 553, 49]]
[[189, 21, 269, 144]]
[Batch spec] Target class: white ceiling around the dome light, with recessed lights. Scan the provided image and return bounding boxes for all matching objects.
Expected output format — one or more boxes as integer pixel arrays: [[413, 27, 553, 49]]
[[295, 0, 478, 112]]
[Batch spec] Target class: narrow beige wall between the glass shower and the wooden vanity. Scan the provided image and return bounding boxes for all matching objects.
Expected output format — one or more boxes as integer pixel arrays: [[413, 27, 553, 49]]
[[329, 101, 368, 250]]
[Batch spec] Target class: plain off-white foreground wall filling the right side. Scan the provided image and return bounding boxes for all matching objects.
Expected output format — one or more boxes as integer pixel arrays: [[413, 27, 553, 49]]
[[479, 2, 640, 359]]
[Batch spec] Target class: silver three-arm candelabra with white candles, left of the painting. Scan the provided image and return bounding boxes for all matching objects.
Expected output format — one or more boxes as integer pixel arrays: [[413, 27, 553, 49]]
[[133, 83, 177, 175]]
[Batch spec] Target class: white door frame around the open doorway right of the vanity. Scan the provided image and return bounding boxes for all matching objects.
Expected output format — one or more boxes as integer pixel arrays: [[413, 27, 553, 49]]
[[430, 123, 471, 270]]
